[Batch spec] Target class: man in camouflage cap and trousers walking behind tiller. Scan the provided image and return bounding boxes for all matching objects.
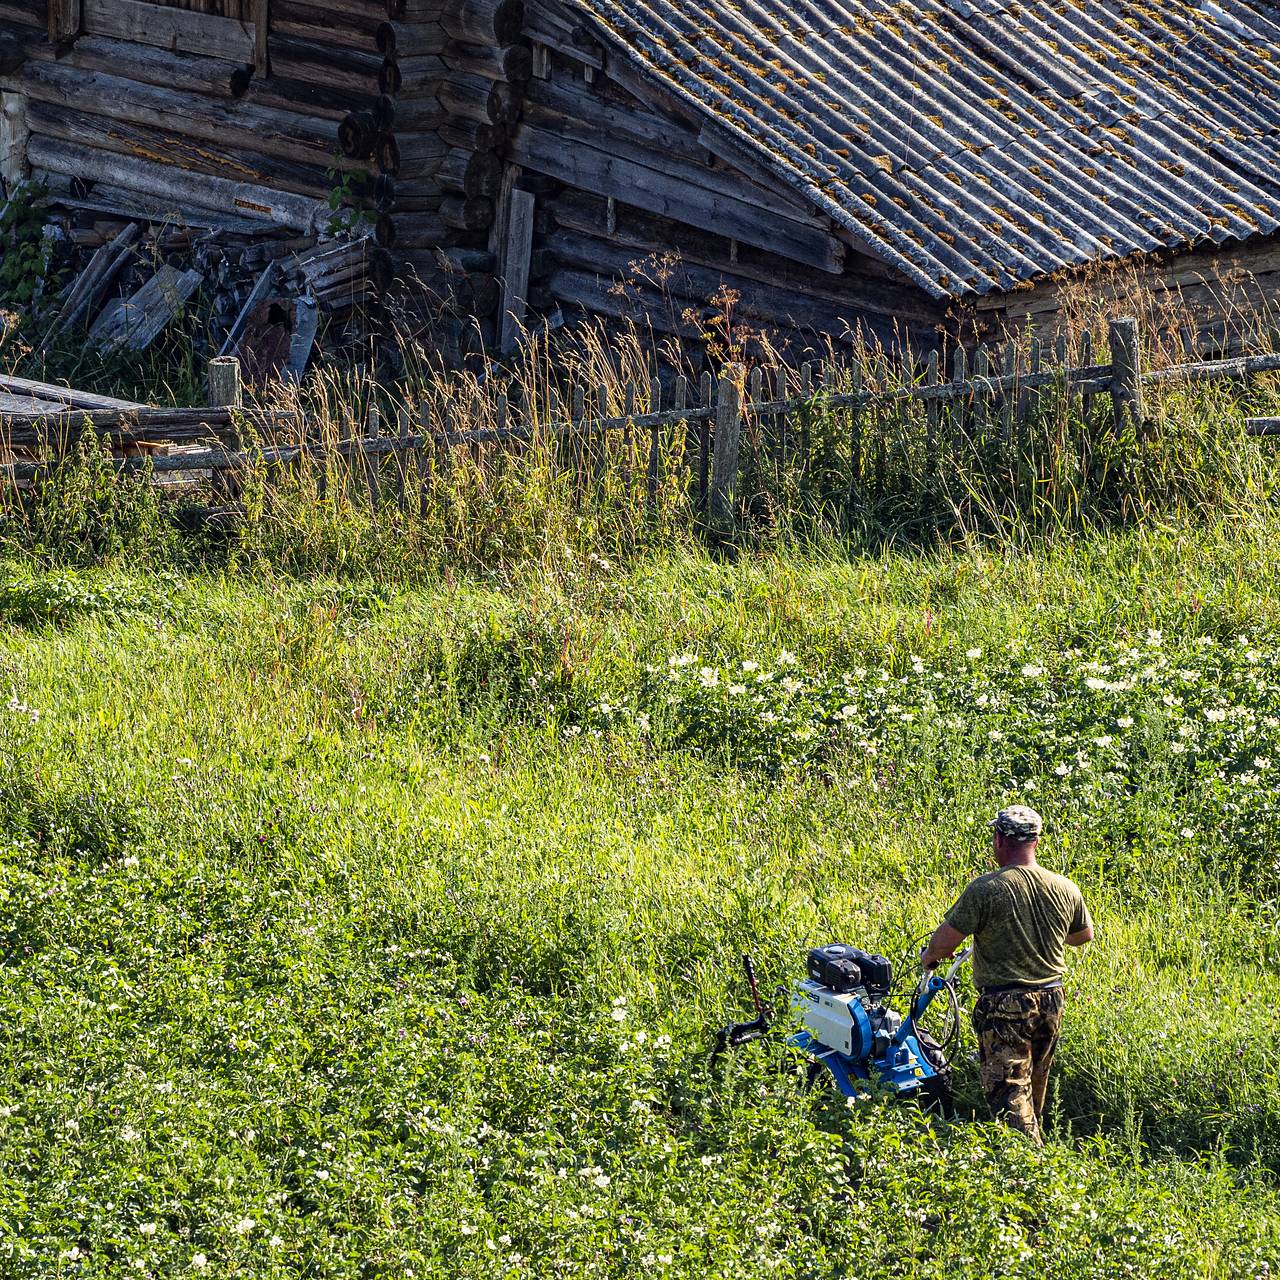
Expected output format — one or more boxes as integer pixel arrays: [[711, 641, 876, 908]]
[[920, 805, 1093, 1146]]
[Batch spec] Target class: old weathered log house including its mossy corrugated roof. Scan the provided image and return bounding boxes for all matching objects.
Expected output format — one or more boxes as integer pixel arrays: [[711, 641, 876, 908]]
[[0, 0, 1280, 351]]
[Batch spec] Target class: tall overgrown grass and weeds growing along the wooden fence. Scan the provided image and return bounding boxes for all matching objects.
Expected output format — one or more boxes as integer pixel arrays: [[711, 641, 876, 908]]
[[0, 320, 1280, 581]]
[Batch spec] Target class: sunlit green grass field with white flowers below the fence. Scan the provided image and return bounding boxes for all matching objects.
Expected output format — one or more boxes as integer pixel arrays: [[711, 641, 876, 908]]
[[0, 520, 1280, 1280]]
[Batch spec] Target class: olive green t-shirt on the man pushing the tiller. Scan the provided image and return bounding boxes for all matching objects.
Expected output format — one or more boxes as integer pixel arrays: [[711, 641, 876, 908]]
[[946, 865, 1093, 987]]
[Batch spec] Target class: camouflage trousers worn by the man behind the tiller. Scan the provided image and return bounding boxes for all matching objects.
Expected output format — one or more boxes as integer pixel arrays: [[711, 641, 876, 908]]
[[973, 987, 1062, 1146]]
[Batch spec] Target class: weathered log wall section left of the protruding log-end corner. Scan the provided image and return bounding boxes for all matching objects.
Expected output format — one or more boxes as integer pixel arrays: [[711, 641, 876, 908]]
[[0, 0, 385, 233]]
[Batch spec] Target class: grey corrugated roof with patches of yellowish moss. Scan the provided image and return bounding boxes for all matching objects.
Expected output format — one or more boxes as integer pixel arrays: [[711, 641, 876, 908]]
[[570, 0, 1280, 297]]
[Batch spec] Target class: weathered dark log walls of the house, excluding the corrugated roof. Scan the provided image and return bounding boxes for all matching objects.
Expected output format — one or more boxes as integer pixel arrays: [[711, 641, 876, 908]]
[[12, 0, 1280, 366]]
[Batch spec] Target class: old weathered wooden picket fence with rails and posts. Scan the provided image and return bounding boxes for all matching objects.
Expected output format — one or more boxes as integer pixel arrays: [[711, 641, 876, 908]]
[[0, 319, 1280, 524]]
